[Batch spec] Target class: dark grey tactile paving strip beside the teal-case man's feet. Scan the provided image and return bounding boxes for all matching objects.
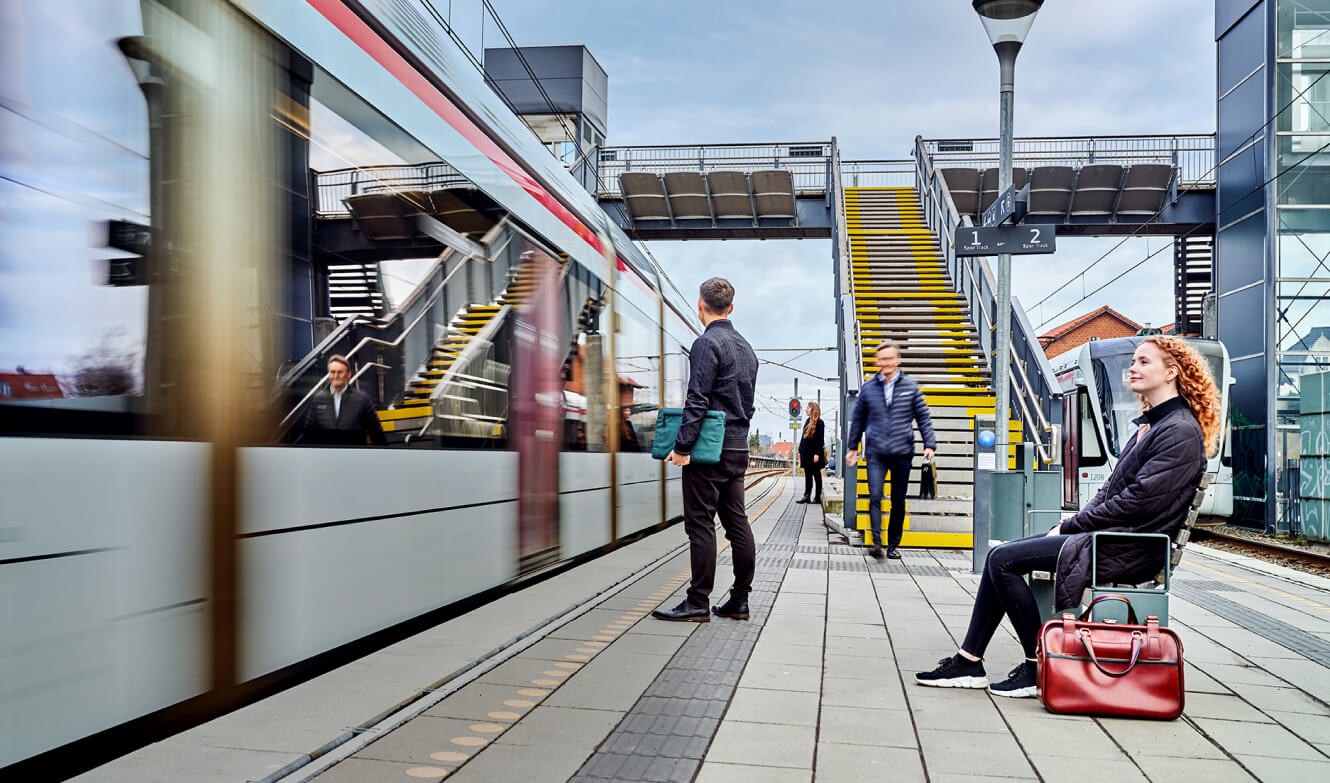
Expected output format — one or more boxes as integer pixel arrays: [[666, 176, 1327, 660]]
[[572, 496, 807, 783]]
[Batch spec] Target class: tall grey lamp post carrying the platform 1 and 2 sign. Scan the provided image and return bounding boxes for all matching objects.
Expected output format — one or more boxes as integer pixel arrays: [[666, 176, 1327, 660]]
[[972, 0, 1044, 471]]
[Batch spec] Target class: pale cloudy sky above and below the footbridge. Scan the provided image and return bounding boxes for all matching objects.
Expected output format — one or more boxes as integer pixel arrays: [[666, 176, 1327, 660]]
[[476, 0, 1216, 444]]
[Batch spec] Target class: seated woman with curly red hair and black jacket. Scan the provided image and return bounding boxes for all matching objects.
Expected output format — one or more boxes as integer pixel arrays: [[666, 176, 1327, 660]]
[[915, 336, 1220, 697]]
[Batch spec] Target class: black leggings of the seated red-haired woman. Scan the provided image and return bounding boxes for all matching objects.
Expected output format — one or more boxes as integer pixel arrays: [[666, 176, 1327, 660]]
[[960, 536, 1068, 658]]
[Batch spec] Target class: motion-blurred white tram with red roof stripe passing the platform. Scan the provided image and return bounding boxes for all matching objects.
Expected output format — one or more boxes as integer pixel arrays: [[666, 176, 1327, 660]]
[[0, 0, 718, 776]]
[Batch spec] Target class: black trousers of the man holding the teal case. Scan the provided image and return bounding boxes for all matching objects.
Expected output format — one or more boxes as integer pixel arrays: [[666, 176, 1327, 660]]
[[684, 451, 757, 606]]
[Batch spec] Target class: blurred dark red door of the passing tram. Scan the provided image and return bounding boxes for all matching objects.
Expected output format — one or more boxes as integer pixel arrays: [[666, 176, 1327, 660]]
[[511, 242, 567, 572]]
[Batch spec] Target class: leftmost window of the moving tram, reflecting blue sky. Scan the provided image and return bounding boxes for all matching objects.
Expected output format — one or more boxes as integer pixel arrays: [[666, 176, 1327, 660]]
[[0, 1, 152, 436]]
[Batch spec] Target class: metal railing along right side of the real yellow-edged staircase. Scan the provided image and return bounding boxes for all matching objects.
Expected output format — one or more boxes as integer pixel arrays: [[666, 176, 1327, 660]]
[[914, 137, 1061, 464]]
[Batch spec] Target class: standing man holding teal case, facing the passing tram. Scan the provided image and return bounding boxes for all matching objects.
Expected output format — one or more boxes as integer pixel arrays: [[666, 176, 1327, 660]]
[[652, 278, 757, 622]]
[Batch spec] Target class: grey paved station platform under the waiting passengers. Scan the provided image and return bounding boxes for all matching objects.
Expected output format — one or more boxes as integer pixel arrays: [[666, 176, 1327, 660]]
[[77, 479, 1330, 783]]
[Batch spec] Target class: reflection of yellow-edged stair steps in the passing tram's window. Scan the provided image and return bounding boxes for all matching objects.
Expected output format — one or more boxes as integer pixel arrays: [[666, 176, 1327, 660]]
[[379, 257, 553, 440]]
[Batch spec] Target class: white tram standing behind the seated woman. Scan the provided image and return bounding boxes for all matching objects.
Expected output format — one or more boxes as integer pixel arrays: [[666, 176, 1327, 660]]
[[1051, 336, 1233, 517]]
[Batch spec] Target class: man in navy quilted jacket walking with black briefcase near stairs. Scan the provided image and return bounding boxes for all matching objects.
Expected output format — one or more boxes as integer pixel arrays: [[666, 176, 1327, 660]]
[[845, 340, 938, 560]]
